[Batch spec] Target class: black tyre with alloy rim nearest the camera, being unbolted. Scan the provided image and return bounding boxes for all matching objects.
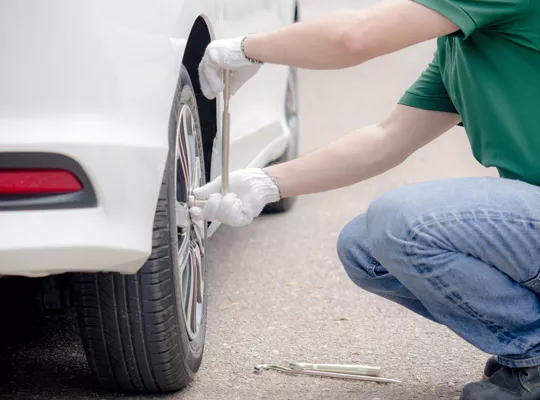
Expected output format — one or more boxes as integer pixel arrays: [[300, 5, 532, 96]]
[[77, 67, 206, 393]]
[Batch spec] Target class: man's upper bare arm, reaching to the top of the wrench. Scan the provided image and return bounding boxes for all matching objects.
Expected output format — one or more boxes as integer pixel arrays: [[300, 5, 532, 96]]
[[245, 0, 458, 69]]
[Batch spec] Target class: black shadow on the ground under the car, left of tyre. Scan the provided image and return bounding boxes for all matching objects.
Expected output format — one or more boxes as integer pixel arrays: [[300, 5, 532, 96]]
[[0, 278, 99, 399]]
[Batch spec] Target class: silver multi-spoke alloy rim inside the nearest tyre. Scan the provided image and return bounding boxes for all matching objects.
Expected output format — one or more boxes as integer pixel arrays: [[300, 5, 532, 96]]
[[174, 105, 206, 340]]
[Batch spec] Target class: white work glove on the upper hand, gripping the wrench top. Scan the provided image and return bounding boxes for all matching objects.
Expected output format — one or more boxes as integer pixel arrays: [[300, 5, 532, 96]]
[[199, 37, 261, 99]]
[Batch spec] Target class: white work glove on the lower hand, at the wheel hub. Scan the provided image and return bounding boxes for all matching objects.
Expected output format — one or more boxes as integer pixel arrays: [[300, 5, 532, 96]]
[[190, 168, 280, 226]]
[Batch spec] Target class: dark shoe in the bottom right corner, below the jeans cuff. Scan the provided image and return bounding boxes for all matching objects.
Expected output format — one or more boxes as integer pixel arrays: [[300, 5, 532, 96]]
[[459, 367, 540, 400]]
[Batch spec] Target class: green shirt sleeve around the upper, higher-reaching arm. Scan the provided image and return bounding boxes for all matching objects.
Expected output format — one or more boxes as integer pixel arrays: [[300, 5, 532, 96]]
[[413, 0, 528, 38]]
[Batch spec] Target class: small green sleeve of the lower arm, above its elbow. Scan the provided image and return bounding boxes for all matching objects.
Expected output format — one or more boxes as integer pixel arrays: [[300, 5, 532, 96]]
[[399, 51, 458, 114]]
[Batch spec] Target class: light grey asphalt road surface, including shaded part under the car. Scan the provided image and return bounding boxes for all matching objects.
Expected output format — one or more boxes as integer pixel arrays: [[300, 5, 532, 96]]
[[0, 0, 493, 400]]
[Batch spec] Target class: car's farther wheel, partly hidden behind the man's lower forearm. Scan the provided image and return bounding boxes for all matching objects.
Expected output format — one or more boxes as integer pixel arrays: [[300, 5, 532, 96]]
[[263, 67, 299, 214]]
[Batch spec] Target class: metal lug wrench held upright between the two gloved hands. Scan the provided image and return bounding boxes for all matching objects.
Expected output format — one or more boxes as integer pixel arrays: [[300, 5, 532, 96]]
[[189, 70, 231, 208]]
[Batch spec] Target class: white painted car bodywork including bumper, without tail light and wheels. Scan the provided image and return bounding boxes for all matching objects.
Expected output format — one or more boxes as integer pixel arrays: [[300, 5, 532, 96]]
[[0, 0, 294, 276]]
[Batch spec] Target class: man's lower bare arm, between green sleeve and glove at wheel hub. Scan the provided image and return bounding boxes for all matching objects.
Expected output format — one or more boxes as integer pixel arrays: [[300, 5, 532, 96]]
[[266, 105, 461, 197]]
